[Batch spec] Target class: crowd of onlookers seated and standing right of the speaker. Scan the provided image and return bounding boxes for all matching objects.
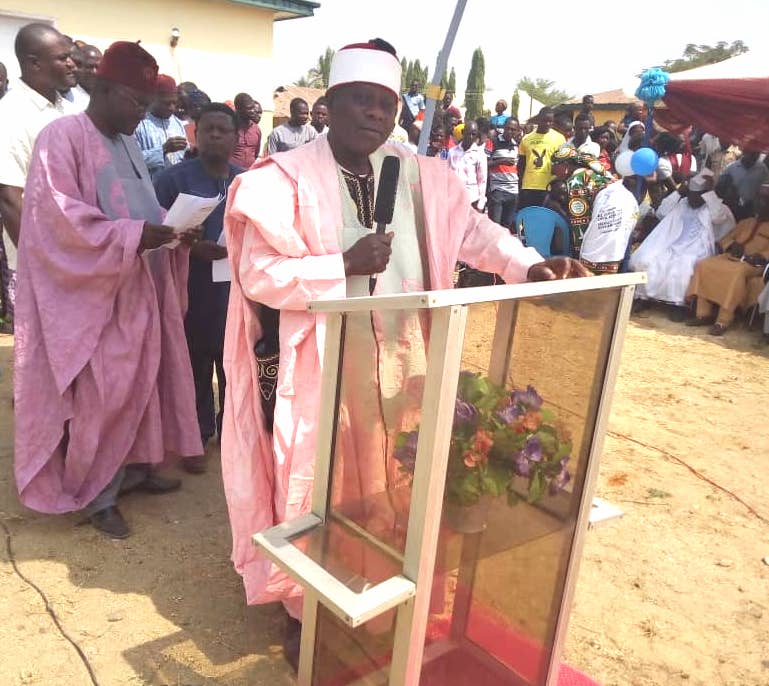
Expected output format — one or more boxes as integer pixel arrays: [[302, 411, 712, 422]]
[[400, 82, 769, 343]]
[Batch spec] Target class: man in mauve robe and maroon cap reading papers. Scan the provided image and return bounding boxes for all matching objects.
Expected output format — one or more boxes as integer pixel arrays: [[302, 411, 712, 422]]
[[15, 43, 202, 538]]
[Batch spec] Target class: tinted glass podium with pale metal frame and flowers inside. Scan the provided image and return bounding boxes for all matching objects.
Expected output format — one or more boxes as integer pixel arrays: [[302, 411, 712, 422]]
[[254, 274, 645, 686]]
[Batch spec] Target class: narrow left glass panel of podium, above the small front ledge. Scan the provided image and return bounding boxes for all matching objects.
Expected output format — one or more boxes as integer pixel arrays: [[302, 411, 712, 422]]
[[328, 310, 430, 560]]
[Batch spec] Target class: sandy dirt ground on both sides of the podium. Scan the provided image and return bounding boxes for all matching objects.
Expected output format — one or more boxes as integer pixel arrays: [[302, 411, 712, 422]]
[[0, 311, 769, 686]]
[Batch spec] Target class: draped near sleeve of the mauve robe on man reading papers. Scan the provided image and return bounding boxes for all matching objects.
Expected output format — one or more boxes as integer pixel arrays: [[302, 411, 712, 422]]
[[19, 118, 144, 393]]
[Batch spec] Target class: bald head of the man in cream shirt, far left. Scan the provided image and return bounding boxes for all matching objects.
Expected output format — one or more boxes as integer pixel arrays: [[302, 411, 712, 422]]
[[14, 22, 77, 97]]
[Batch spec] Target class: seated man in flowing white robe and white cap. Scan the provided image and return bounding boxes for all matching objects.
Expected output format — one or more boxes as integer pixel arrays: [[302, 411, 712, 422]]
[[630, 175, 734, 321]]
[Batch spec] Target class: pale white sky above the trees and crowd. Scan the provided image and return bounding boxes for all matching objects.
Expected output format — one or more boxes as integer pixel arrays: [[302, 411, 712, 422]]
[[273, 0, 769, 104]]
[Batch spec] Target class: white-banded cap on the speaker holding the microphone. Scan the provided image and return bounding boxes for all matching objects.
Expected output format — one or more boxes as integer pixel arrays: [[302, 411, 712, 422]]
[[328, 41, 401, 98]]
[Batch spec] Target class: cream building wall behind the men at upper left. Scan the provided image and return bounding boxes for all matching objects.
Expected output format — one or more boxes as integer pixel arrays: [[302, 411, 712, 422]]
[[0, 0, 276, 135]]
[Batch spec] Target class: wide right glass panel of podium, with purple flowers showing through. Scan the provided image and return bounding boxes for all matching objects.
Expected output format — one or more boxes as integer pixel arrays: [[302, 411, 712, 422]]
[[420, 291, 619, 686]]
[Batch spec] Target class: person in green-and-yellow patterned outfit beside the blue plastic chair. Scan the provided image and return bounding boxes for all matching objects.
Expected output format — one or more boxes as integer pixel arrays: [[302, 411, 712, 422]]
[[551, 144, 615, 257]]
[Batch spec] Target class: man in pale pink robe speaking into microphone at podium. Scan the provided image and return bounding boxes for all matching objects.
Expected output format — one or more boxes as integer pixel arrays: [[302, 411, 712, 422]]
[[222, 39, 587, 668]]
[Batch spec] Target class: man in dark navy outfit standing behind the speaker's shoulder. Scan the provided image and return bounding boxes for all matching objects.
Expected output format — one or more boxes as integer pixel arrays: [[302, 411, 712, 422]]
[[154, 103, 243, 473]]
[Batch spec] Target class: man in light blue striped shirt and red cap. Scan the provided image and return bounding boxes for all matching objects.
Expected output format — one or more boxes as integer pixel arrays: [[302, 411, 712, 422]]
[[134, 74, 187, 179]]
